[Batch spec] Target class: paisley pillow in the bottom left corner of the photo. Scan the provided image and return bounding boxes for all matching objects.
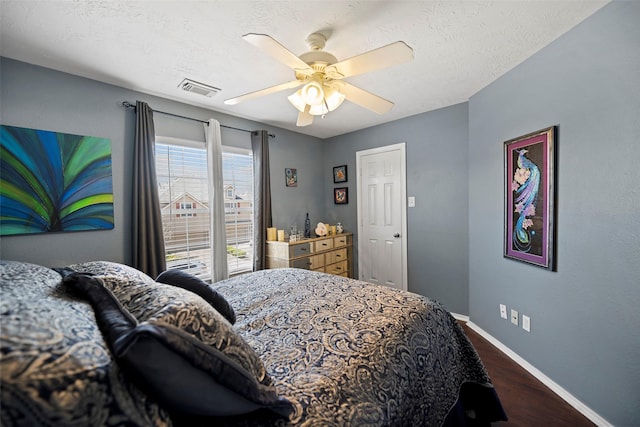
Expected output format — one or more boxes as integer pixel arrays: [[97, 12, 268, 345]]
[[0, 260, 171, 427]]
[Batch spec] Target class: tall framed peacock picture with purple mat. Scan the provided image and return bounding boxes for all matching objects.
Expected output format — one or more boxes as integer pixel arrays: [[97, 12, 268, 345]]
[[504, 126, 556, 271]]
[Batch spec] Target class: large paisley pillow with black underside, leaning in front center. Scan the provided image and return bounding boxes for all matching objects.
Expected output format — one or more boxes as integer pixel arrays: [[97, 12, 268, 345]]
[[64, 273, 292, 416]]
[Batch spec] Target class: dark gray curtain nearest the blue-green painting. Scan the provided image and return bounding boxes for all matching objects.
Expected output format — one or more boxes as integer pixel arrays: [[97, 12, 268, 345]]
[[131, 101, 167, 278]]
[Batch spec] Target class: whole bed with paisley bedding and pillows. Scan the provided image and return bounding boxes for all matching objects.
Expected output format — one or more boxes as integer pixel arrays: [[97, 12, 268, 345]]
[[0, 262, 506, 426]]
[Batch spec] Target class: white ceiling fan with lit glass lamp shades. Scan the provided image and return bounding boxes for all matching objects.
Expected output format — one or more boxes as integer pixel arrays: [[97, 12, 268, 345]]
[[224, 33, 413, 126]]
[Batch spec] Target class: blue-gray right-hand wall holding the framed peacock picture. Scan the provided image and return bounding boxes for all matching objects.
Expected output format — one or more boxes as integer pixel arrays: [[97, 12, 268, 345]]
[[469, 2, 640, 426]]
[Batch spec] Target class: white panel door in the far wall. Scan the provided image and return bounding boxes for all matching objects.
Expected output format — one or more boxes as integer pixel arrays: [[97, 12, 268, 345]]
[[356, 144, 407, 290]]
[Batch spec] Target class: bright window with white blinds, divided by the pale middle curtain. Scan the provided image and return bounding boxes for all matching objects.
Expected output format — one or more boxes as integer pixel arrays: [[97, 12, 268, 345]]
[[156, 137, 253, 281]]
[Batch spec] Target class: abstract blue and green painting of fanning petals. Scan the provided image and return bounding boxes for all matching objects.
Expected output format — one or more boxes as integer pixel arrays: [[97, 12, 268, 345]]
[[0, 125, 113, 236]]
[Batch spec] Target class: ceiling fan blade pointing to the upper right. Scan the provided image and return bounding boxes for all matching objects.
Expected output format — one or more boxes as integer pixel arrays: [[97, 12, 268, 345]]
[[325, 41, 413, 79]]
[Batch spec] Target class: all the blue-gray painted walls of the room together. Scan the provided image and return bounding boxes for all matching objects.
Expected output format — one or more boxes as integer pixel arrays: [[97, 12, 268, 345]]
[[0, 2, 640, 426]]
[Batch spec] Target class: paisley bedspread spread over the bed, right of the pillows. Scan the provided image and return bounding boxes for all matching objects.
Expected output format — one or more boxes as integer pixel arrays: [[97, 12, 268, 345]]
[[213, 269, 504, 426]]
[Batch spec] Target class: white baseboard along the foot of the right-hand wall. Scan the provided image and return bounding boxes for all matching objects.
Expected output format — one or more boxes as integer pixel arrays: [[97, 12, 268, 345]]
[[464, 320, 613, 427]]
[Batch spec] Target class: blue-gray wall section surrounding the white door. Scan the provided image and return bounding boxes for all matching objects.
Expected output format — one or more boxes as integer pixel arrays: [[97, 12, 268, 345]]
[[324, 103, 469, 314]]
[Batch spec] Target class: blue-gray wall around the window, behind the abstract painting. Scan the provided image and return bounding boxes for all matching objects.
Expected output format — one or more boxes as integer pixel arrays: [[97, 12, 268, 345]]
[[0, 58, 324, 266]]
